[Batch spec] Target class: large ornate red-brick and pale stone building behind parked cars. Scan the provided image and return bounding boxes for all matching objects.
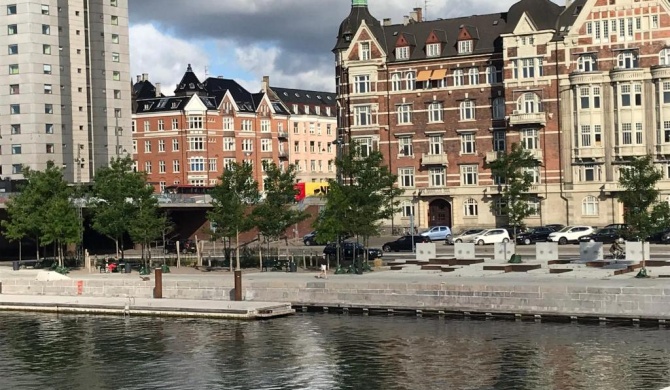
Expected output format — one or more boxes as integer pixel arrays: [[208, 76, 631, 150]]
[[334, 0, 670, 227]]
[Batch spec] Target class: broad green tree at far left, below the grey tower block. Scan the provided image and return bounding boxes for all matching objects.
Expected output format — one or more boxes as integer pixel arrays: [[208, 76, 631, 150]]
[[2, 161, 82, 264]]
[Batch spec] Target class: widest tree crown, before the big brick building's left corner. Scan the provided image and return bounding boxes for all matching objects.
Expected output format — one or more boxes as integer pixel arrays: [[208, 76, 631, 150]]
[[315, 144, 402, 241]]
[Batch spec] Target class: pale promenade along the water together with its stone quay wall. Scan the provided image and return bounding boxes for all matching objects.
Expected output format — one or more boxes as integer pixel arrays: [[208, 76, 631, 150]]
[[0, 267, 670, 323]]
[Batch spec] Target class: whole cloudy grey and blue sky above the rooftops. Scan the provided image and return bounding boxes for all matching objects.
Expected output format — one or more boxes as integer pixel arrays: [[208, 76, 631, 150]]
[[129, 0, 563, 95]]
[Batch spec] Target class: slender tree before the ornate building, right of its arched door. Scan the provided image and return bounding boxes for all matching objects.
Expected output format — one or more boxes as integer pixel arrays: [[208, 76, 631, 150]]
[[489, 144, 539, 241]]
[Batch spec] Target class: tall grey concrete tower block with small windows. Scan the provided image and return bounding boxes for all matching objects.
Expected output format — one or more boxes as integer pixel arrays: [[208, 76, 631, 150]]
[[0, 0, 131, 182]]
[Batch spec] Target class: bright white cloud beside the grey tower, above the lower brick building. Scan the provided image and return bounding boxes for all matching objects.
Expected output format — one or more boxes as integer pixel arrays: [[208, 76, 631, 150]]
[[130, 24, 208, 95]]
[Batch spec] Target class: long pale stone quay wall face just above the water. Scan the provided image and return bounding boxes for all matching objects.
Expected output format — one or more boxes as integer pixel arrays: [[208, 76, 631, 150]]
[[0, 279, 670, 321]]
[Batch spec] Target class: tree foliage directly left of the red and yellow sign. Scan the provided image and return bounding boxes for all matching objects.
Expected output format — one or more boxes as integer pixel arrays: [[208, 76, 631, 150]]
[[252, 161, 309, 240]]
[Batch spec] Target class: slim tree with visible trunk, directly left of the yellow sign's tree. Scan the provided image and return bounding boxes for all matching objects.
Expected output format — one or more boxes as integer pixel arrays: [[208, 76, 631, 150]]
[[207, 162, 260, 271]]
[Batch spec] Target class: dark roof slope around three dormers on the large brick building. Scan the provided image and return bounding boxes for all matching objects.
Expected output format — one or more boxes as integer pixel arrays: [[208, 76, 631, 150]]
[[384, 12, 506, 60]]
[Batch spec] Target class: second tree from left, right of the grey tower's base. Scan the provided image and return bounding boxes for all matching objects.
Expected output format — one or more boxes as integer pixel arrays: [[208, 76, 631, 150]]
[[89, 156, 153, 258]]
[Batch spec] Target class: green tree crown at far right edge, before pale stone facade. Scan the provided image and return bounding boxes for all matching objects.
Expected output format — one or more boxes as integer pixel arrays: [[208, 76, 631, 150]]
[[617, 156, 670, 240]]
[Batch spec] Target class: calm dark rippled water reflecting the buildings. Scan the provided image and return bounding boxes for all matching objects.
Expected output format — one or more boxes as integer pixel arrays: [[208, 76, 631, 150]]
[[0, 313, 670, 390]]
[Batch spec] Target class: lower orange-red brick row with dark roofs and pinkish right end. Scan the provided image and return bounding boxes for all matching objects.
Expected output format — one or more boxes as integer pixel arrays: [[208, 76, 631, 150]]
[[132, 65, 335, 192]]
